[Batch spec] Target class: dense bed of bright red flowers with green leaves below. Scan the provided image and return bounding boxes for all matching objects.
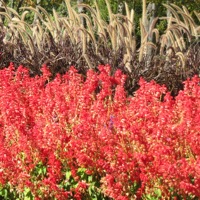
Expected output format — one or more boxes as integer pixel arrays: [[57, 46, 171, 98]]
[[0, 63, 200, 200]]
